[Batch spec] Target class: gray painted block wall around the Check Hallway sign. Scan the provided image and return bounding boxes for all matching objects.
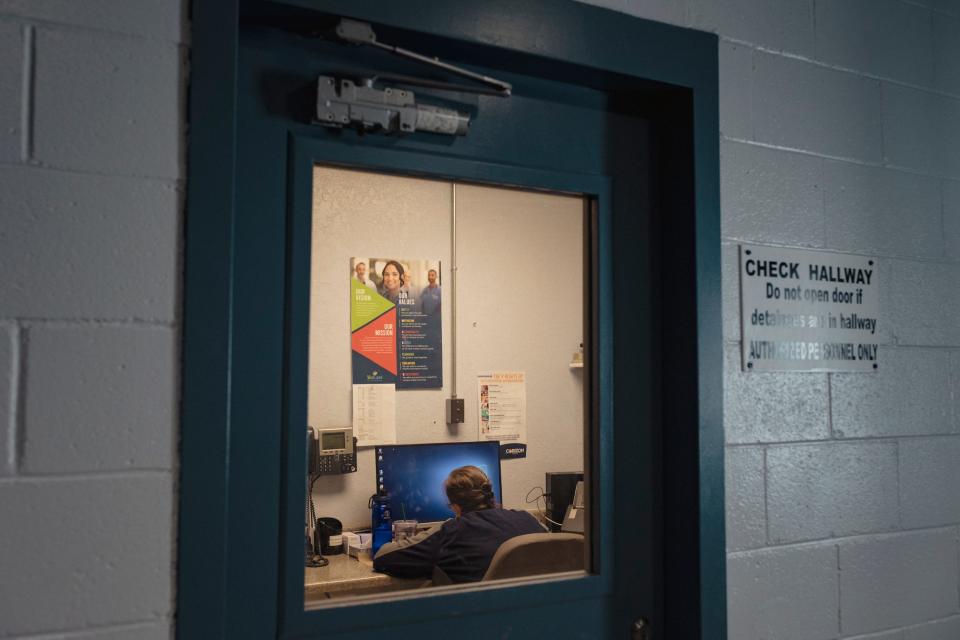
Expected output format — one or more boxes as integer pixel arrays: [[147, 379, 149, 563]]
[[580, 0, 960, 640]]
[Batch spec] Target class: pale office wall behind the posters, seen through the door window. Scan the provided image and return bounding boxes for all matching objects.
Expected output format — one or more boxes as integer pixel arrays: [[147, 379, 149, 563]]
[[307, 167, 583, 527]]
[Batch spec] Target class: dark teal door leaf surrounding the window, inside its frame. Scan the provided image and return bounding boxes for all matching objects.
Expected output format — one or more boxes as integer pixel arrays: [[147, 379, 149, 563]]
[[248, 23, 654, 638]]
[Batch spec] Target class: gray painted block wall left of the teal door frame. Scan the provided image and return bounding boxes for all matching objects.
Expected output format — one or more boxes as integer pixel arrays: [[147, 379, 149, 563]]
[[0, 0, 187, 640]]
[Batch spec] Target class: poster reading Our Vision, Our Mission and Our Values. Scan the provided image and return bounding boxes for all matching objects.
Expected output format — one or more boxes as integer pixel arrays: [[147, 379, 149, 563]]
[[350, 257, 443, 390]]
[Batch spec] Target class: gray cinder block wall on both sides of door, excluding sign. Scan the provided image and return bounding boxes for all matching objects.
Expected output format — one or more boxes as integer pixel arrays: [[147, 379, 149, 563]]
[[0, 0, 960, 640]]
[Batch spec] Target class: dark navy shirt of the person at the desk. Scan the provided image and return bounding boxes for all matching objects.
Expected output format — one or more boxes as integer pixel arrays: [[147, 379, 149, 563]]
[[373, 509, 544, 583]]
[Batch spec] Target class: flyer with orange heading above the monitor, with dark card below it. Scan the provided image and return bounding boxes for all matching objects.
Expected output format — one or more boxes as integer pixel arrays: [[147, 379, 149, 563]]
[[477, 371, 527, 459]]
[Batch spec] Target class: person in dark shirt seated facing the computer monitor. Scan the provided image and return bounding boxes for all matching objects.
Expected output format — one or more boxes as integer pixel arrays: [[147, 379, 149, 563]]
[[373, 466, 544, 583]]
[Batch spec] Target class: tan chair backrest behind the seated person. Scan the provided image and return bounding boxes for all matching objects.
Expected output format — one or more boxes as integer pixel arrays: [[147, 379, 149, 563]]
[[483, 533, 584, 580]]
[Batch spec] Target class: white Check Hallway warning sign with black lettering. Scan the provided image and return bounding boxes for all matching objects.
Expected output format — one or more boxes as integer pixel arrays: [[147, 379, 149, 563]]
[[740, 245, 880, 371]]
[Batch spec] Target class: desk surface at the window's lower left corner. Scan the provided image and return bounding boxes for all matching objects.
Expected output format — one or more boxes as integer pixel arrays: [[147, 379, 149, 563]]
[[304, 554, 424, 600]]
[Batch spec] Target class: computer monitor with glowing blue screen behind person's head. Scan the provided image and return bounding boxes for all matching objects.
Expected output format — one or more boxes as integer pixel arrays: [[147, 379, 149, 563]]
[[376, 441, 501, 522]]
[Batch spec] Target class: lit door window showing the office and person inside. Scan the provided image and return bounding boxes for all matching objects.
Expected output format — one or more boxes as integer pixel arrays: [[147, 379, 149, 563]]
[[304, 166, 590, 608]]
